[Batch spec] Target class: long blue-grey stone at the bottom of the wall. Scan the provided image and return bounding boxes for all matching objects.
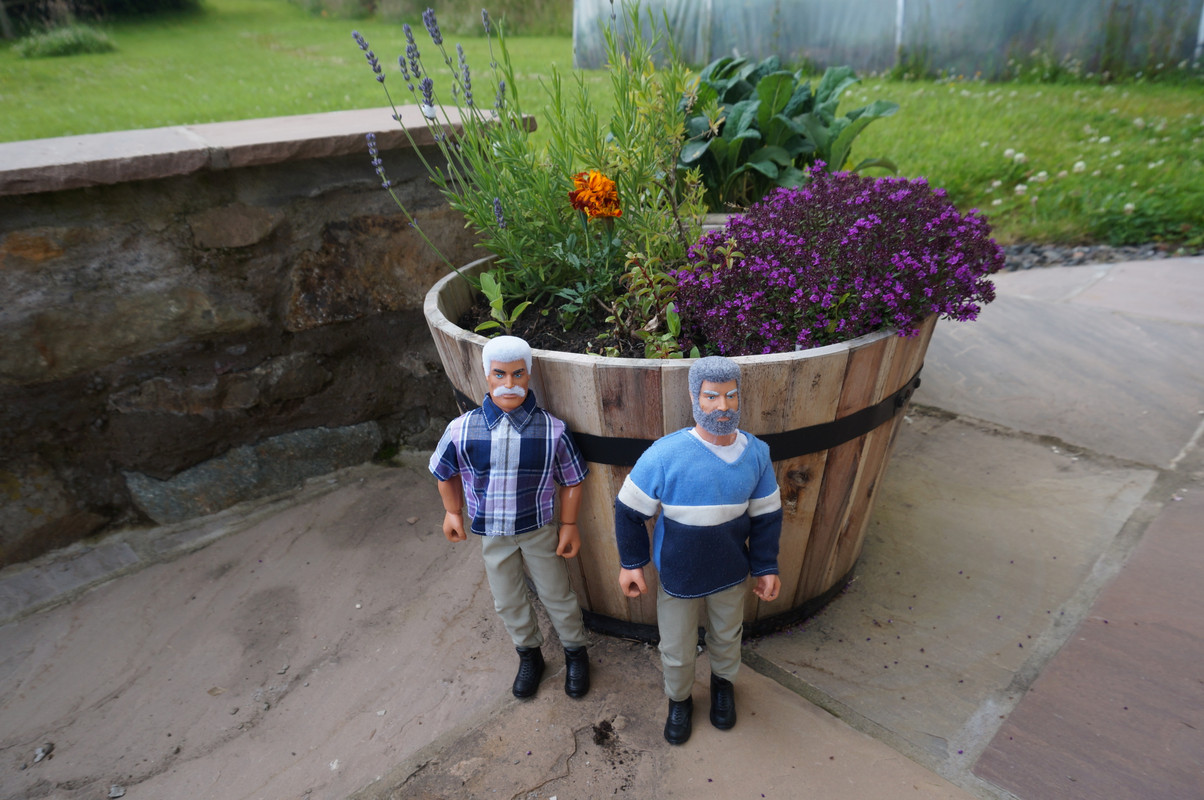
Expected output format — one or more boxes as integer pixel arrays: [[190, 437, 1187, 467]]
[[125, 422, 383, 524]]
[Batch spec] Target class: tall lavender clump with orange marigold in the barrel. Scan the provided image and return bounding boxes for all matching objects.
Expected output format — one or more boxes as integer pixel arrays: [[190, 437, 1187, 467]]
[[353, 2, 706, 339]]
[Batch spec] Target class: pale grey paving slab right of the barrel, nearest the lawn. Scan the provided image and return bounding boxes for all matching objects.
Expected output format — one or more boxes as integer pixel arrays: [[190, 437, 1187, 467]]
[[915, 259, 1204, 467]]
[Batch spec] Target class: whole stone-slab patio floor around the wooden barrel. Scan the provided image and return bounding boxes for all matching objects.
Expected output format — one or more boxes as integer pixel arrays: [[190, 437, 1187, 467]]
[[0, 258, 1204, 800]]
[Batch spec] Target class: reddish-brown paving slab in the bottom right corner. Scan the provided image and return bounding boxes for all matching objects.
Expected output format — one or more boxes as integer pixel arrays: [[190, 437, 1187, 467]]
[[974, 482, 1204, 800]]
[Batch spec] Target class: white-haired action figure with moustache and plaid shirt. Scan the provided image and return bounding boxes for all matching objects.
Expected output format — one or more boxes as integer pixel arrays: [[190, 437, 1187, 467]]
[[430, 336, 590, 698]]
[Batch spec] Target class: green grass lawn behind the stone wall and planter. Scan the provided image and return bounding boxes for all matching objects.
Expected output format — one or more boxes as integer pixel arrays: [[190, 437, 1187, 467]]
[[0, 0, 1204, 247]]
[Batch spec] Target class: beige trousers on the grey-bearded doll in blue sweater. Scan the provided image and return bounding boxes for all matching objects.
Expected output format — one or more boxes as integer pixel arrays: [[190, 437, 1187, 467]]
[[656, 583, 744, 701]]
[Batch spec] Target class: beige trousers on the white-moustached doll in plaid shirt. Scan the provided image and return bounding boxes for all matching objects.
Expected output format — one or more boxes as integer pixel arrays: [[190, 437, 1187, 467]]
[[480, 523, 586, 647]]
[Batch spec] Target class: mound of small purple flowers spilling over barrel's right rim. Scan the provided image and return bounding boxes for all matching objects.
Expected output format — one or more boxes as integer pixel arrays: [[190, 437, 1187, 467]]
[[674, 163, 1004, 355]]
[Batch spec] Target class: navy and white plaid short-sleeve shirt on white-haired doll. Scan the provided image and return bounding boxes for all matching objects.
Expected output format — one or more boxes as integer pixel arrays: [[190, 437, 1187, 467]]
[[430, 392, 589, 536]]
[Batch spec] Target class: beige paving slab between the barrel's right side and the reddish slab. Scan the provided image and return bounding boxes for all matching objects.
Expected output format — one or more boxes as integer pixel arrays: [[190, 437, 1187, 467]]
[[749, 413, 1157, 786]]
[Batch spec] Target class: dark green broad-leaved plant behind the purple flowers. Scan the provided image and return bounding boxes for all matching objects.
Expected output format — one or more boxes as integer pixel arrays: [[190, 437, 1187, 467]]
[[679, 57, 898, 211]]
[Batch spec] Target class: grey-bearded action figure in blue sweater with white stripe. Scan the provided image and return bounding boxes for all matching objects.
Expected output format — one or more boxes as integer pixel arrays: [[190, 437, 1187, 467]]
[[614, 357, 781, 745]]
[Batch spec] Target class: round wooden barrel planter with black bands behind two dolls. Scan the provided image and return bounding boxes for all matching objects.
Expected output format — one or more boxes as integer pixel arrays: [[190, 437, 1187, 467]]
[[425, 259, 936, 641]]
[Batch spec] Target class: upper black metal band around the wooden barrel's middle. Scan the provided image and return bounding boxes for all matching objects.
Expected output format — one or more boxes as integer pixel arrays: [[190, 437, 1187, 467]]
[[454, 367, 923, 466]]
